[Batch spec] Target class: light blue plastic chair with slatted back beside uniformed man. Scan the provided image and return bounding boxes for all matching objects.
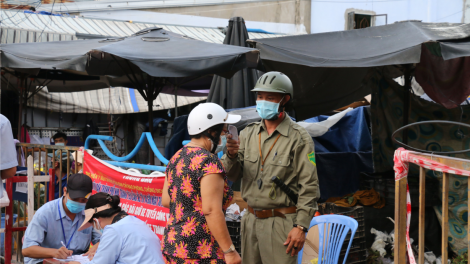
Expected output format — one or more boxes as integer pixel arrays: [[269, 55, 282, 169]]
[[297, 215, 358, 264]]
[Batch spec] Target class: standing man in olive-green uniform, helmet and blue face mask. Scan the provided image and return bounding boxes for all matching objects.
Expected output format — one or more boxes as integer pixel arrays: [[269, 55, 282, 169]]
[[222, 72, 320, 264]]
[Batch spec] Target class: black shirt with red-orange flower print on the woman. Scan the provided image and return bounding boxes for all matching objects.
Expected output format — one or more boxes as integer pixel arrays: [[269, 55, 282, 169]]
[[162, 146, 233, 259]]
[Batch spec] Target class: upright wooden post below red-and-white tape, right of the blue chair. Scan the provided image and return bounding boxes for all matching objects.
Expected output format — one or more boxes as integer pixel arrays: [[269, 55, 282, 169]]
[[394, 178, 408, 263]]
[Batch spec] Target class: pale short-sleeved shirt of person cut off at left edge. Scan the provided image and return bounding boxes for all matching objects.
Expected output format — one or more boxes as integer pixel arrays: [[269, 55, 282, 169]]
[[0, 114, 18, 197]]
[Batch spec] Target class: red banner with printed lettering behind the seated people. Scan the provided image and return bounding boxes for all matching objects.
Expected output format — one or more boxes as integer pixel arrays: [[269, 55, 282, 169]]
[[83, 151, 169, 239]]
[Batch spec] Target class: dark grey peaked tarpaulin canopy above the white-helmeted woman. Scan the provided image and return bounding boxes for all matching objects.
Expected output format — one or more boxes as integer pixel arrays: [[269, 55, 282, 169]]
[[87, 28, 259, 79]]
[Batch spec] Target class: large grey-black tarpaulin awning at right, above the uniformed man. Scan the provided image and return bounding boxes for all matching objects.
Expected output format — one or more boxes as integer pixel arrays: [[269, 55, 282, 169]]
[[249, 22, 470, 120]]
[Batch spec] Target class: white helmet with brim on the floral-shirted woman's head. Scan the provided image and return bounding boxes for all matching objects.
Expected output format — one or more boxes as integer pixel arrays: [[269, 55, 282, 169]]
[[188, 103, 242, 135]]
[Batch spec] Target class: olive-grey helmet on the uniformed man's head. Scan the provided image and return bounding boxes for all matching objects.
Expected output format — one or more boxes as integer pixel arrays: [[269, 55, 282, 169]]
[[251, 72, 294, 98]]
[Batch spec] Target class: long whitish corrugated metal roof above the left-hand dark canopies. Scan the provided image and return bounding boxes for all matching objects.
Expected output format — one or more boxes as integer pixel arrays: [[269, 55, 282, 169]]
[[0, 10, 283, 43]]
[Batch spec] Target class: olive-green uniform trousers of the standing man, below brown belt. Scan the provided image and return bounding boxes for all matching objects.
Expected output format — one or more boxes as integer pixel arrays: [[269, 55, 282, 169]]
[[241, 212, 297, 264]]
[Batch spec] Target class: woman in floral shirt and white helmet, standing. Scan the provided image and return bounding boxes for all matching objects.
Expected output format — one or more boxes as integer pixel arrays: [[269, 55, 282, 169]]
[[162, 103, 241, 264]]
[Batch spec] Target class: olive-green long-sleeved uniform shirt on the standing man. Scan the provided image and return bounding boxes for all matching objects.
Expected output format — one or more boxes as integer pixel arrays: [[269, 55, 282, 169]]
[[222, 115, 320, 228]]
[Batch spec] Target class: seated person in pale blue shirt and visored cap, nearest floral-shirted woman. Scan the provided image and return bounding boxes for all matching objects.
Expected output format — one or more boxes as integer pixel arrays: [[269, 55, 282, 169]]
[[69, 192, 164, 264]]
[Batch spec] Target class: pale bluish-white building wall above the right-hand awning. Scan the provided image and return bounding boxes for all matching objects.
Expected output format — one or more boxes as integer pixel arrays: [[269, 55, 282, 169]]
[[311, 0, 464, 33]]
